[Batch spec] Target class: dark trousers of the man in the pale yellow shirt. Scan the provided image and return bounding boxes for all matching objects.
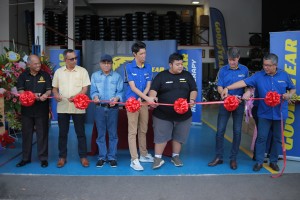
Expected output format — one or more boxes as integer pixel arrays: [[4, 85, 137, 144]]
[[58, 113, 87, 158]]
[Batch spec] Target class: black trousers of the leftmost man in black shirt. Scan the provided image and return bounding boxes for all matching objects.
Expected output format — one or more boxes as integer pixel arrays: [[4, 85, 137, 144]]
[[22, 115, 49, 161]]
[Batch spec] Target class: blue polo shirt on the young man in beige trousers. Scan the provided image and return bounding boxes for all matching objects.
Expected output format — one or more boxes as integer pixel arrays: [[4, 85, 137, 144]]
[[125, 59, 152, 100]]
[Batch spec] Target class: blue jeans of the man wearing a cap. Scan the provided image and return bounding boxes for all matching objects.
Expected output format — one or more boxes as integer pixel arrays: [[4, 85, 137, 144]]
[[95, 106, 119, 160]]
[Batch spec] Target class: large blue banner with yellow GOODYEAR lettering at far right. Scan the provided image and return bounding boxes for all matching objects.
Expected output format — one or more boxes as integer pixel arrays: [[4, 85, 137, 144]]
[[270, 31, 300, 160]]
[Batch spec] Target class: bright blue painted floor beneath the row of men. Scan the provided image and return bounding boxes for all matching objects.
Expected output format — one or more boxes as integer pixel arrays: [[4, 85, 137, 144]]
[[0, 124, 270, 176]]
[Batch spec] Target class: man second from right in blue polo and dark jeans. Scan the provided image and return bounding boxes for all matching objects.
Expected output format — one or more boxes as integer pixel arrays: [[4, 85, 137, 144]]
[[208, 47, 249, 170]]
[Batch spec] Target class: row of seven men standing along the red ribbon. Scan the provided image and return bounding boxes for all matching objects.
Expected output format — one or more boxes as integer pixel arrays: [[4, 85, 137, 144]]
[[17, 42, 295, 171]]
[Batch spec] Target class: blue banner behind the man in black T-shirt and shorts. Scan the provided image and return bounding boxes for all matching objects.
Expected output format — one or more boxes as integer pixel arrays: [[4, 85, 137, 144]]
[[179, 49, 202, 123]]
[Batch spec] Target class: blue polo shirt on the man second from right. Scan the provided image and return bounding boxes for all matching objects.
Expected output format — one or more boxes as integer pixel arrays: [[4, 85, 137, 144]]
[[217, 64, 249, 96]]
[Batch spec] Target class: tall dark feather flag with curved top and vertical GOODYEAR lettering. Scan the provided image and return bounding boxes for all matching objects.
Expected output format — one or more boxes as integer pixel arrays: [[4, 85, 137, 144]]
[[210, 8, 228, 68]]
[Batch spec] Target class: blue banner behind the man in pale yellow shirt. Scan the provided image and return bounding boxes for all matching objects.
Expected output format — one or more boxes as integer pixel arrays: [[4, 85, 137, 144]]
[[50, 49, 80, 121]]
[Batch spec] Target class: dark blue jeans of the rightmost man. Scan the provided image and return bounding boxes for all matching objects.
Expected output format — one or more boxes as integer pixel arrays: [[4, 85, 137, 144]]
[[255, 118, 281, 164]]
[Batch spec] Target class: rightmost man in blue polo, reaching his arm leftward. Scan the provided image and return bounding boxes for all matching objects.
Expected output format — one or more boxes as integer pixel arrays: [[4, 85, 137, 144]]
[[221, 53, 296, 171]]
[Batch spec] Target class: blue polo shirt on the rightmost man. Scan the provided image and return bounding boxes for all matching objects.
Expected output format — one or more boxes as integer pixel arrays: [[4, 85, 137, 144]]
[[244, 69, 295, 120]]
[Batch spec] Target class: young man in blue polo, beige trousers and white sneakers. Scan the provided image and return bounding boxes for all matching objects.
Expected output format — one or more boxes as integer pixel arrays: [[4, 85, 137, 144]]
[[125, 42, 156, 171]]
